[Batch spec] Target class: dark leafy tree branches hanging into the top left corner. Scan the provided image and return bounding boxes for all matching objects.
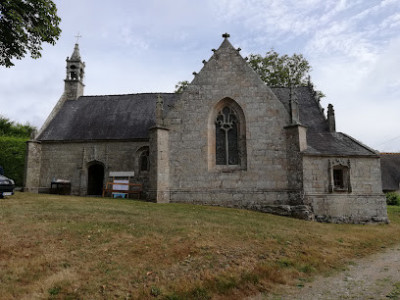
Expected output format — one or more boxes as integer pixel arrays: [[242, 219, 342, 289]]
[[0, 0, 61, 67]]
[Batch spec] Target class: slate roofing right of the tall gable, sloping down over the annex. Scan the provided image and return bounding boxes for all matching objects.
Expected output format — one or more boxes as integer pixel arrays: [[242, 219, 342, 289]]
[[271, 86, 378, 156]]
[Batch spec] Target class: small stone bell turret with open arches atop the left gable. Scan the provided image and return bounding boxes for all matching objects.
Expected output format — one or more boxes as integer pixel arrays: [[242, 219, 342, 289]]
[[64, 43, 85, 100]]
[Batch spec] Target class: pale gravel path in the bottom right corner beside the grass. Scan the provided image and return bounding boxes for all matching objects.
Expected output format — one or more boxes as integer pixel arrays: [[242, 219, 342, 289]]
[[252, 245, 400, 300]]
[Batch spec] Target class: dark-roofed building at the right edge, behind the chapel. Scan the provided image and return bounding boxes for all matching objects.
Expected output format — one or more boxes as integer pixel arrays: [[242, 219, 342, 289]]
[[381, 153, 400, 191]]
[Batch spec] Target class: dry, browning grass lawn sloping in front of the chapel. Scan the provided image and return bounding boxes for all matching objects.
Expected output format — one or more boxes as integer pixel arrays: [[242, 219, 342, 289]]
[[0, 193, 400, 299]]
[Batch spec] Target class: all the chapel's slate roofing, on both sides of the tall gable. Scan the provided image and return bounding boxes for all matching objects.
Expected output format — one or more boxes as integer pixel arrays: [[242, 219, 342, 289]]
[[37, 81, 377, 156]]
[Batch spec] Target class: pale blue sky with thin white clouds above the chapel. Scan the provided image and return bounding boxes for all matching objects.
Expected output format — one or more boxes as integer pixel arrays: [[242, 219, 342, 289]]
[[0, 0, 400, 152]]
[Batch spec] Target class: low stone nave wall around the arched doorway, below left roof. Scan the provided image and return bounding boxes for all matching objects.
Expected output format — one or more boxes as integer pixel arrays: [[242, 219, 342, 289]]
[[26, 141, 149, 195]]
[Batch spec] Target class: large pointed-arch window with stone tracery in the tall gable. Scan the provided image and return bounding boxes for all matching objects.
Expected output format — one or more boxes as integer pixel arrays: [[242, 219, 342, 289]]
[[215, 106, 240, 165]]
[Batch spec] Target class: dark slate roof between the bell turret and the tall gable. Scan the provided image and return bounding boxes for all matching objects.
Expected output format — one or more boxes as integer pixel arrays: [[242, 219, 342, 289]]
[[37, 93, 180, 141]]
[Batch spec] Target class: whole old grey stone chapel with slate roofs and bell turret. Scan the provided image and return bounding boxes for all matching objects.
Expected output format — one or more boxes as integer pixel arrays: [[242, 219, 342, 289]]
[[24, 34, 388, 223]]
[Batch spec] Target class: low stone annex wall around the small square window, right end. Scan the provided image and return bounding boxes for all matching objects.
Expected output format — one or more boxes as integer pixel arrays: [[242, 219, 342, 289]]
[[303, 156, 388, 223]]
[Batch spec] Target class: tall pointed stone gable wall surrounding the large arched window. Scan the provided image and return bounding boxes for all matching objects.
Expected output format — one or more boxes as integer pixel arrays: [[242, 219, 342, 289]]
[[165, 40, 289, 207]]
